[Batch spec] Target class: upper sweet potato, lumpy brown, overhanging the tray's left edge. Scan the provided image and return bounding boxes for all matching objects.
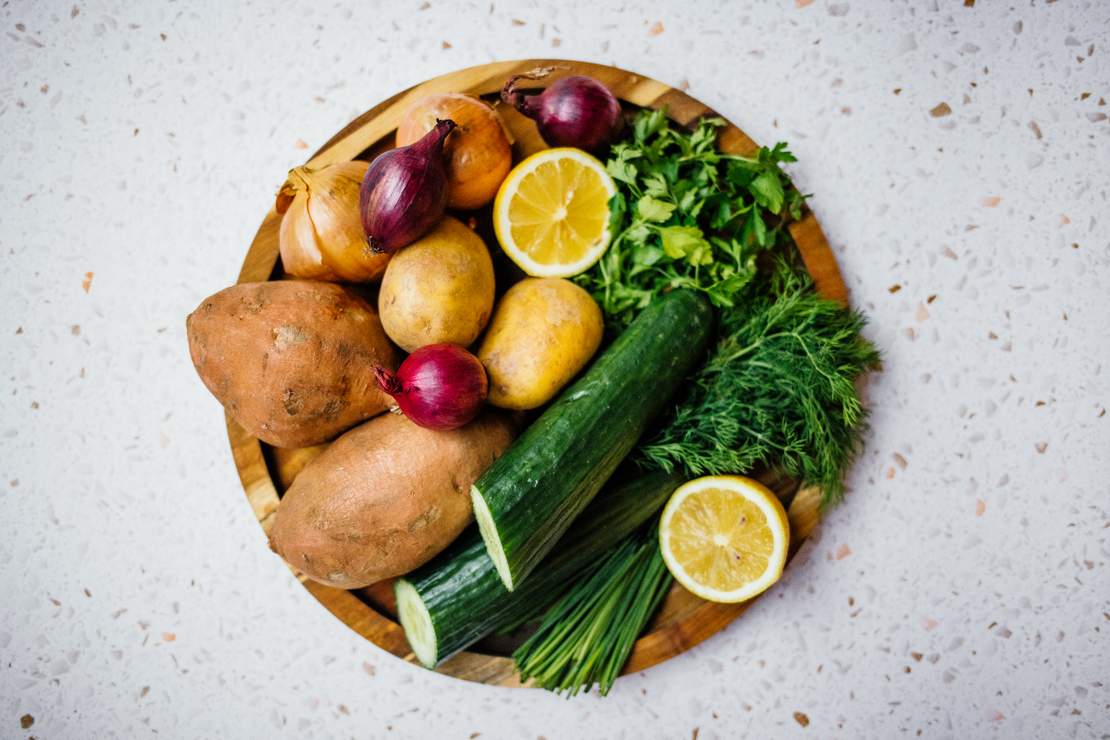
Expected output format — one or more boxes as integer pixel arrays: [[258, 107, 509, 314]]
[[185, 281, 397, 447]]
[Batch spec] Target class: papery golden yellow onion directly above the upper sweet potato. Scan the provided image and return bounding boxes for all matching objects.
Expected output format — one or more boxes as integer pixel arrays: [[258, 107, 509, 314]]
[[276, 162, 390, 283]]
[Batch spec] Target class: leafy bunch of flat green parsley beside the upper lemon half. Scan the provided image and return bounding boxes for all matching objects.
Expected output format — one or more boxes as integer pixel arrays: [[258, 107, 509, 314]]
[[575, 110, 805, 328]]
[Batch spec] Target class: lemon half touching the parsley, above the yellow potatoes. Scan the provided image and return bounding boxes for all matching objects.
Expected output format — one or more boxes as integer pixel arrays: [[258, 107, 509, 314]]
[[493, 146, 616, 277]]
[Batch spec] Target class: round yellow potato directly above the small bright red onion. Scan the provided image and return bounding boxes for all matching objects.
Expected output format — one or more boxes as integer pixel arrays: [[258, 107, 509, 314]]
[[377, 216, 494, 352]]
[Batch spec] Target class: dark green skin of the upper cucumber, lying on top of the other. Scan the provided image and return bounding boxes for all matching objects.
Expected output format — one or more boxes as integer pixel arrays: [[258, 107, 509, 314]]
[[475, 291, 713, 588]]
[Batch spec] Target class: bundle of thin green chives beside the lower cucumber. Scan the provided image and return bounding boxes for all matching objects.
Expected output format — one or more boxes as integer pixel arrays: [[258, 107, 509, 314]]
[[513, 523, 672, 696]]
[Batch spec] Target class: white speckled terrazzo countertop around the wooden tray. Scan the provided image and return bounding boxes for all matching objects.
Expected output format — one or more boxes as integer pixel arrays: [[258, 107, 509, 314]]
[[0, 0, 1110, 740]]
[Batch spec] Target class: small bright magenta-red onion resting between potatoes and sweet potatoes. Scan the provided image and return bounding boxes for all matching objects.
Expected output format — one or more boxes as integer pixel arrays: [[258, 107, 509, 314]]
[[374, 344, 490, 429]]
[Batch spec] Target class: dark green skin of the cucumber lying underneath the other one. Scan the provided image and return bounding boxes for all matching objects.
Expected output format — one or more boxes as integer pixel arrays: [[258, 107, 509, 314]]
[[402, 473, 685, 663]]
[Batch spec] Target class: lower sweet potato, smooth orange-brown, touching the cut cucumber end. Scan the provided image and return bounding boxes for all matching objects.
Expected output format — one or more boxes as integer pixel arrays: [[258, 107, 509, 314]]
[[270, 408, 514, 588]]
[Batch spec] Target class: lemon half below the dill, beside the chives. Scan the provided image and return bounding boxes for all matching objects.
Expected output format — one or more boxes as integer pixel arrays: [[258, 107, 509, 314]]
[[659, 475, 790, 604]]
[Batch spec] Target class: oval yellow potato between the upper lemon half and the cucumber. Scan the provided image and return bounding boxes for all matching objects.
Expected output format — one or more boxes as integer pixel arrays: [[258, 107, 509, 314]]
[[477, 277, 605, 410]]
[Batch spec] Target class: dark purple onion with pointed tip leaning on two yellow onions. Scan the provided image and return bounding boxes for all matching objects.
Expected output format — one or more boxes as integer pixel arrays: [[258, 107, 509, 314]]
[[359, 120, 455, 253]]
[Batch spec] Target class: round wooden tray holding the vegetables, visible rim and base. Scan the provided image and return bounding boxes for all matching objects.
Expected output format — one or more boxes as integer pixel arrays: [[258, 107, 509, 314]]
[[228, 59, 846, 687]]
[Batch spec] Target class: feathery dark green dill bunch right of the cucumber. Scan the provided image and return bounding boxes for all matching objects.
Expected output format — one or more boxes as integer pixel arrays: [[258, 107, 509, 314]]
[[638, 259, 880, 506]]
